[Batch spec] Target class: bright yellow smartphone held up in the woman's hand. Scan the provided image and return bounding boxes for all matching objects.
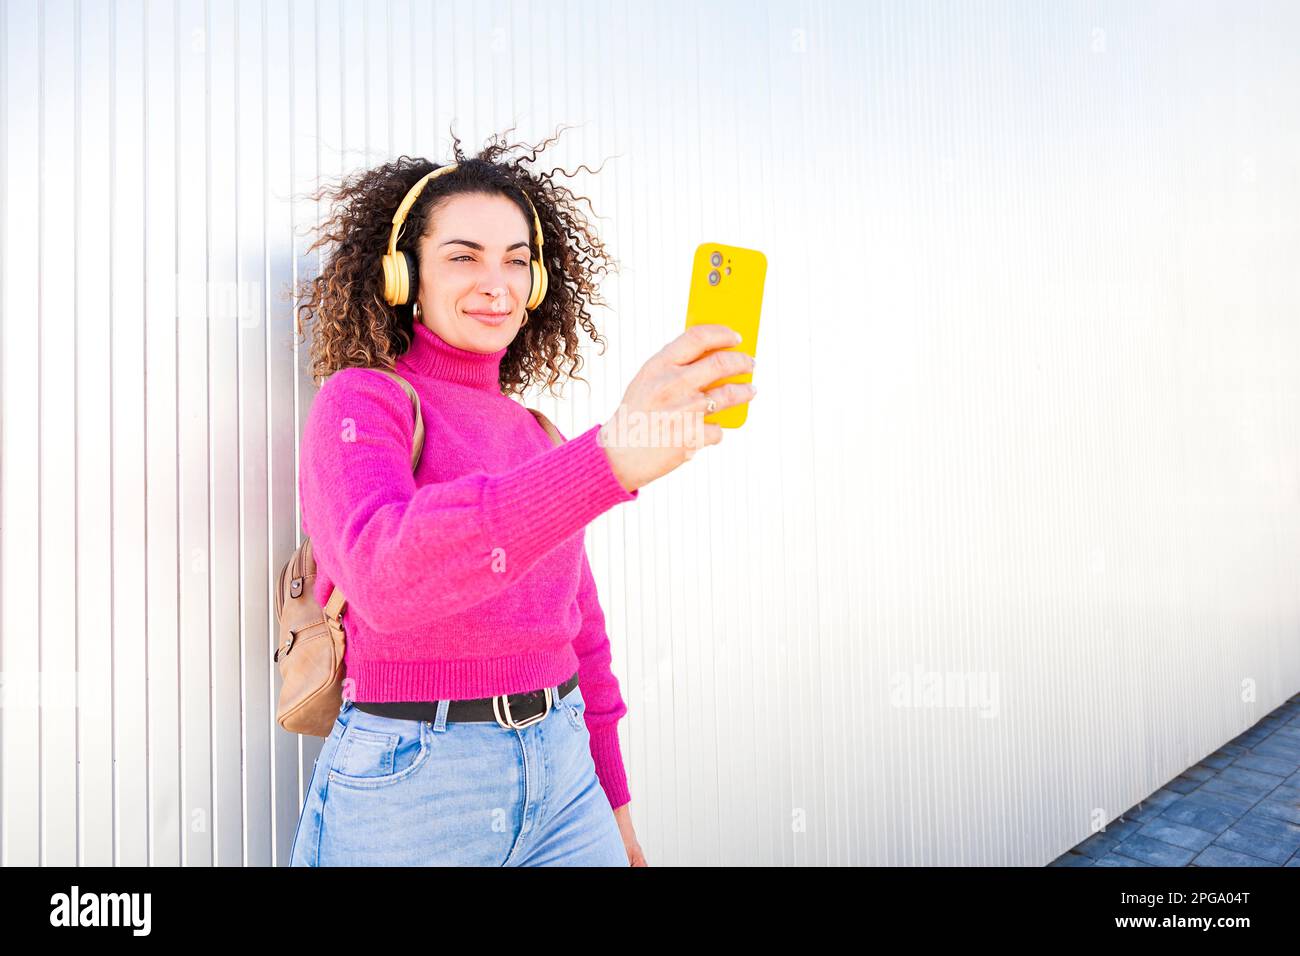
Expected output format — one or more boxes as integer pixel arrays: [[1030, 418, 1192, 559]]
[[686, 242, 767, 428]]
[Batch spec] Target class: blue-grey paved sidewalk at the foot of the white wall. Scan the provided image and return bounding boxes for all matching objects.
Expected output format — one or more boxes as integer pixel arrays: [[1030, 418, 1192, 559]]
[[1048, 695, 1300, 868]]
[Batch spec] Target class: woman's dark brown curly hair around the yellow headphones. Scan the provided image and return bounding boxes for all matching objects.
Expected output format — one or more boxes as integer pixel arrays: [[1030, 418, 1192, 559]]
[[295, 127, 618, 395]]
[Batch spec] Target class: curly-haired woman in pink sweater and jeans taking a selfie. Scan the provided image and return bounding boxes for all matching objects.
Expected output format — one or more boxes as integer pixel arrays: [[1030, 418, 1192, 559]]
[[284, 130, 754, 866]]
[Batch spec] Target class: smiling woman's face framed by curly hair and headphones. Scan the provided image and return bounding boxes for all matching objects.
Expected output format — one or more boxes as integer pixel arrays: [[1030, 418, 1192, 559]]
[[419, 193, 532, 352]]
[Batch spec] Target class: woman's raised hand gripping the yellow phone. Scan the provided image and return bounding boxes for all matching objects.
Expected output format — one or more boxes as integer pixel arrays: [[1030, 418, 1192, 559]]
[[599, 324, 755, 492]]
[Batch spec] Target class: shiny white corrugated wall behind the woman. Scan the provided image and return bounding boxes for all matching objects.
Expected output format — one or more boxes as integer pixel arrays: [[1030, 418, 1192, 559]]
[[0, 0, 1300, 865]]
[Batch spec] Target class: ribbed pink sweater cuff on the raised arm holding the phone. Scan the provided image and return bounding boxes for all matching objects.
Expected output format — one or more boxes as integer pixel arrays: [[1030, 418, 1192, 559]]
[[482, 425, 641, 568]]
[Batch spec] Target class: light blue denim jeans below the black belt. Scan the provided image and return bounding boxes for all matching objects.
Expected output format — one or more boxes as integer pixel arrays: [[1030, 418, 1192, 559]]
[[289, 687, 628, 866]]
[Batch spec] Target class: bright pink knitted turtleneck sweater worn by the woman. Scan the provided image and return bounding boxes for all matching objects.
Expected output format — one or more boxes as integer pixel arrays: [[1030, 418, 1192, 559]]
[[298, 323, 638, 808]]
